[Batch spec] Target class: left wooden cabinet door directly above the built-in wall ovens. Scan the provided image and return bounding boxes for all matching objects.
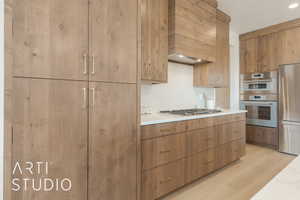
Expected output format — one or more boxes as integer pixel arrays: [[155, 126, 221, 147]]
[[240, 38, 258, 74]]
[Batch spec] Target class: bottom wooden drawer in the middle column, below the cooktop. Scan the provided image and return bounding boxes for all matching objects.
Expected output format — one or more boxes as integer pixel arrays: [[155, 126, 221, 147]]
[[185, 148, 217, 183]]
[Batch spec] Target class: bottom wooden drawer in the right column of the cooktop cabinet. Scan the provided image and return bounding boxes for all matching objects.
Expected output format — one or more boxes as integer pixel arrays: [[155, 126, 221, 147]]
[[217, 139, 245, 168]]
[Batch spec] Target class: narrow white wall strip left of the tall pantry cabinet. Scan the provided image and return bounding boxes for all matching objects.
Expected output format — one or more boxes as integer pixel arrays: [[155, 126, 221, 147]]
[[0, 0, 4, 200]]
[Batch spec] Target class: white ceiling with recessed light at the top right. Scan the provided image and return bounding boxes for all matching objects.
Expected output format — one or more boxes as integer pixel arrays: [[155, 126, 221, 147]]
[[218, 0, 300, 34]]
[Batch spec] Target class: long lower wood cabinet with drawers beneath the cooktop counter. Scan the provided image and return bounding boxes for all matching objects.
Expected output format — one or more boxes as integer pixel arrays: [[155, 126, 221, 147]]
[[141, 113, 246, 200]]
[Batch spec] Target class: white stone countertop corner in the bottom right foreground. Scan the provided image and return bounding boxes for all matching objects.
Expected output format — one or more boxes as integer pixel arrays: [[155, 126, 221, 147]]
[[251, 156, 300, 200]]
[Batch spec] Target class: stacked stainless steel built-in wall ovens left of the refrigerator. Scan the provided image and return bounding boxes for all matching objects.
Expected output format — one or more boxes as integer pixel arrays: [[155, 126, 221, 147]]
[[240, 71, 278, 128]]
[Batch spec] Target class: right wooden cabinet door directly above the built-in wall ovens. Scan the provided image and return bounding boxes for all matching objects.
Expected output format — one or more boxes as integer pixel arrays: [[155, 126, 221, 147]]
[[258, 33, 279, 72]]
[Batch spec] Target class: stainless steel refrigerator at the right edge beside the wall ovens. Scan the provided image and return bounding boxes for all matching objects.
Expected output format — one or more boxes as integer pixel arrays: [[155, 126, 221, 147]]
[[279, 64, 300, 155]]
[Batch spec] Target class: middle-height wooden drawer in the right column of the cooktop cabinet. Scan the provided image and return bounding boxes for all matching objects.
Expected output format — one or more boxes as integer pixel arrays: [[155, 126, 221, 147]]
[[216, 121, 246, 144]]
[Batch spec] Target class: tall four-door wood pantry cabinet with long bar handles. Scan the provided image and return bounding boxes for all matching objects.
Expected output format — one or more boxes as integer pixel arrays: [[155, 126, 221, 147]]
[[5, 0, 141, 200]]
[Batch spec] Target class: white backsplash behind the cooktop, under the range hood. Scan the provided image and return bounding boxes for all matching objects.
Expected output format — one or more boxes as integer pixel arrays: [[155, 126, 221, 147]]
[[141, 63, 215, 112]]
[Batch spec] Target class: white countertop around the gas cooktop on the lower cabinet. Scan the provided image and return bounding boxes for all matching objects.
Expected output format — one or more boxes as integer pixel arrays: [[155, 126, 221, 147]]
[[141, 110, 247, 126]]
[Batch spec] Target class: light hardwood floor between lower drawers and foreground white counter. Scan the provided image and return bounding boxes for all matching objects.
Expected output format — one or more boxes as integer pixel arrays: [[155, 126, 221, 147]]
[[163, 145, 295, 200]]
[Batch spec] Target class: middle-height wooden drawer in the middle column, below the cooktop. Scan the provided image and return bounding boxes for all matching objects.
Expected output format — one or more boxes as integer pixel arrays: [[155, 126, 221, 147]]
[[187, 127, 218, 155]]
